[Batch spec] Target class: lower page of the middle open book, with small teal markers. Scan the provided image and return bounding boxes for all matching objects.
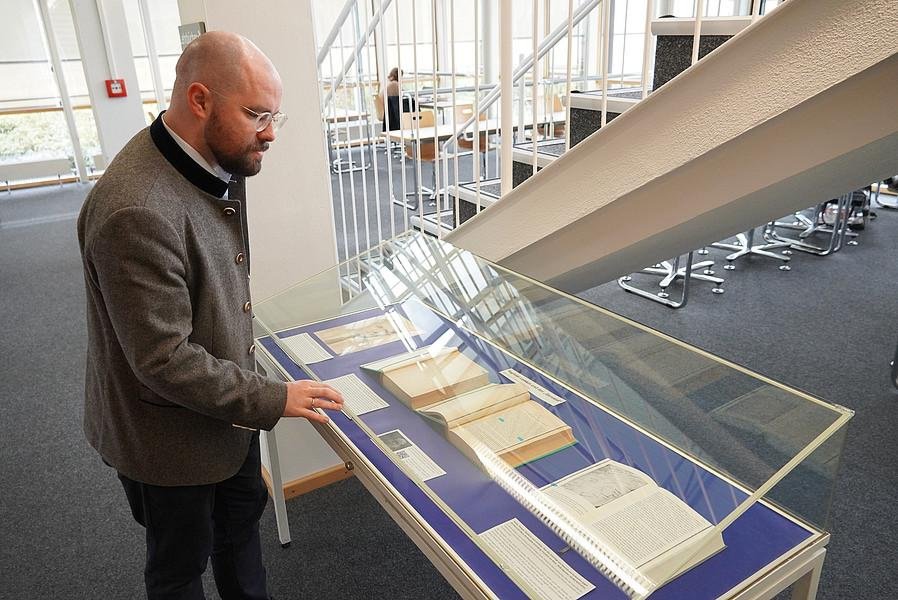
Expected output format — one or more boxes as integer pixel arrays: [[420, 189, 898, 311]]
[[452, 400, 567, 454]]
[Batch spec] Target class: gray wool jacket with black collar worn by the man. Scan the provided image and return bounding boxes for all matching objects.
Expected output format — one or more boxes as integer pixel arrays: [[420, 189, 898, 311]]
[[78, 115, 287, 486]]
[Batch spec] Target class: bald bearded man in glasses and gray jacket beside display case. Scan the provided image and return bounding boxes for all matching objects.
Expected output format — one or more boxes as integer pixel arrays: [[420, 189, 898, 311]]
[[78, 32, 343, 600]]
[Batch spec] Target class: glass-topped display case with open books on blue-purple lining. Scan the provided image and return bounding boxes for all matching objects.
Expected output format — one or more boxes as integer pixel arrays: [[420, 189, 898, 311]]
[[254, 233, 852, 599]]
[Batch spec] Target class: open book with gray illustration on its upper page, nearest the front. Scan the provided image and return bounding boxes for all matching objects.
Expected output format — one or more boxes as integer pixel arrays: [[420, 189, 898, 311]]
[[542, 459, 725, 585]]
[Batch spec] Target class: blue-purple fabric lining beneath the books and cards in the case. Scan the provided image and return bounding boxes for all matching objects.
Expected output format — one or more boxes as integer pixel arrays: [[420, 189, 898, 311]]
[[262, 302, 813, 599]]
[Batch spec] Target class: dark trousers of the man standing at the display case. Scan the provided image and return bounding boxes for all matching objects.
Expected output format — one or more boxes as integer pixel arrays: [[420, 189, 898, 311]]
[[119, 436, 268, 600]]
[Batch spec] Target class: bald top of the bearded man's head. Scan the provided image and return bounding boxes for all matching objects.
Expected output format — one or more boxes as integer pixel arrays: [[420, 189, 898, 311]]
[[172, 31, 280, 103]]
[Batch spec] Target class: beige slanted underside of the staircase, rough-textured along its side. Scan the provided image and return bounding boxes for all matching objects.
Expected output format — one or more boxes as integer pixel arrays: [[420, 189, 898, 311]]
[[447, 0, 898, 292]]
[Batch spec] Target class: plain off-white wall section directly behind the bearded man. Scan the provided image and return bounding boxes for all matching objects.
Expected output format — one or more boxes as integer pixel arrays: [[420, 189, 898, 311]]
[[179, 0, 342, 482]]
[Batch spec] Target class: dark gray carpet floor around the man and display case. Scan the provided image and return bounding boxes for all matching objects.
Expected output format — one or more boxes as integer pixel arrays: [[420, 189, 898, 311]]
[[0, 184, 898, 600]]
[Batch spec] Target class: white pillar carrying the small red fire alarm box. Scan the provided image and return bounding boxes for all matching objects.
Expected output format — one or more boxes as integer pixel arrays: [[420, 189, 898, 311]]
[[69, 0, 146, 160]]
